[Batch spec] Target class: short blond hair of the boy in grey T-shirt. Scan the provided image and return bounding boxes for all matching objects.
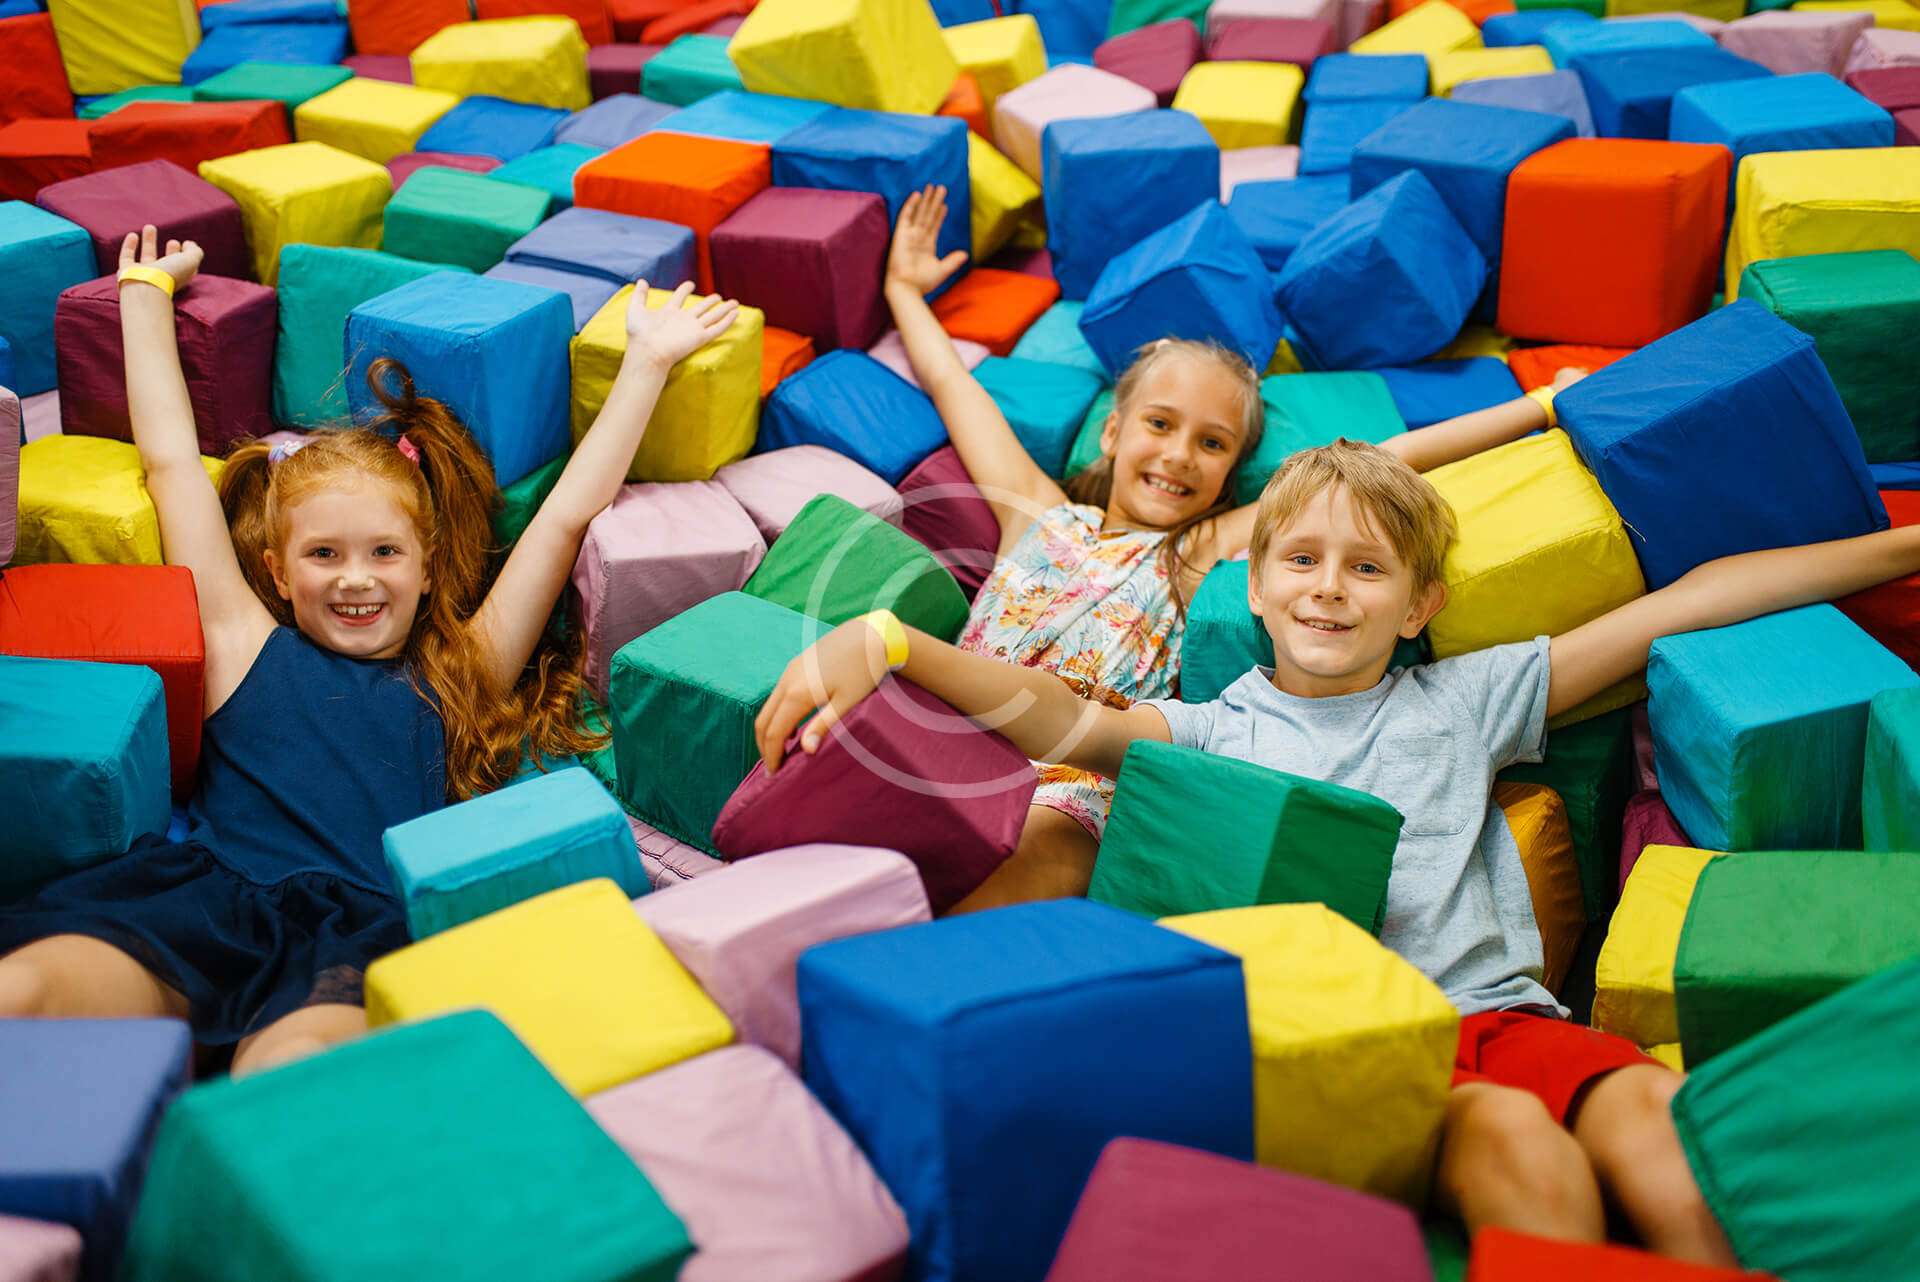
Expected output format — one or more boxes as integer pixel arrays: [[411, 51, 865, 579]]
[[1248, 438, 1459, 595]]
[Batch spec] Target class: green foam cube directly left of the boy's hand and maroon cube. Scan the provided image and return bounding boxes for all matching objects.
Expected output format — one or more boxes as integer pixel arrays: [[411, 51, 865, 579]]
[[607, 591, 806, 852]]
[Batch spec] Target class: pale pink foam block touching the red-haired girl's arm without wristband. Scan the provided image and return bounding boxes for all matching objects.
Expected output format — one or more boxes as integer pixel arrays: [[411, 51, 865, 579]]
[[574, 482, 766, 699]]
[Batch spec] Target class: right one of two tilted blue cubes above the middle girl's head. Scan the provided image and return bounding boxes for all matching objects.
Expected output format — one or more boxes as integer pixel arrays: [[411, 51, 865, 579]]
[[1275, 169, 1486, 370]]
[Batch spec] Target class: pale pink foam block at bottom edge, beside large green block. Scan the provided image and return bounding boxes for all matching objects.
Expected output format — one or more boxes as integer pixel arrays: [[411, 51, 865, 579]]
[[586, 1044, 906, 1282]]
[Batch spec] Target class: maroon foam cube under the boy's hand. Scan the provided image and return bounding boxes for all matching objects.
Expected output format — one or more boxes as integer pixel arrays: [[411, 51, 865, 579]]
[[712, 679, 1035, 914]]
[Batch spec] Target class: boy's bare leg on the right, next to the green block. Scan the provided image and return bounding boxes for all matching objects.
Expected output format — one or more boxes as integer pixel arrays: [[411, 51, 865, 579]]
[[1572, 1063, 1740, 1269]]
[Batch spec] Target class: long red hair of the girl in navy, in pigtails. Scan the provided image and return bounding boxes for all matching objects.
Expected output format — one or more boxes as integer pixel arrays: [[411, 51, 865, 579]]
[[219, 357, 605, 800]]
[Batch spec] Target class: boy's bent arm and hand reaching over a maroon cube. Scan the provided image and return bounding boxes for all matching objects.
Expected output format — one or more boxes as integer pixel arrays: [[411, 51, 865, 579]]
[[753, 618, 1167, 777]]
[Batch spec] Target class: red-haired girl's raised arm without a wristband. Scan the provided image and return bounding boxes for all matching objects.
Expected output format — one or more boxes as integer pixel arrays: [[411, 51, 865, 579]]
[[472, 280, 739, 689]]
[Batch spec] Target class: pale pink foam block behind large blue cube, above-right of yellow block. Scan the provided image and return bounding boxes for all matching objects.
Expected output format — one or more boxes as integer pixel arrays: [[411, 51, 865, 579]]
[[634, 844, 927, 1067]]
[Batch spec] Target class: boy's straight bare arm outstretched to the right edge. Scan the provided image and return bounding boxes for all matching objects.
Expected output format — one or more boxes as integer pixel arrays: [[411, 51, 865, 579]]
[[1548, 526, 1920, 716]]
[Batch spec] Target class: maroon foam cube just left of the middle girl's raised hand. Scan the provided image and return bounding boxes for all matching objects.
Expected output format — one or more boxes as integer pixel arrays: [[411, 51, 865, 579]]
[[712, 186, 891, 351]]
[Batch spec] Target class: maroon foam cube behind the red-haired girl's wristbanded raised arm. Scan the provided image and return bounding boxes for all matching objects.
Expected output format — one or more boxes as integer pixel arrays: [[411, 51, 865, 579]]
[[54, 274, 280, 457]]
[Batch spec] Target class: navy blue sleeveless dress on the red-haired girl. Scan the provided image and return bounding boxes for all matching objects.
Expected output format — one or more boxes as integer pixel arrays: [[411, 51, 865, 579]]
[[0, 628, 447, 1046]]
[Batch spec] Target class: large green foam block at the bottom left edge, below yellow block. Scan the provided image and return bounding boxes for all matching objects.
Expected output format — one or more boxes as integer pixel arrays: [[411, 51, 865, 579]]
[[121, 1011, 693, 1282]]
